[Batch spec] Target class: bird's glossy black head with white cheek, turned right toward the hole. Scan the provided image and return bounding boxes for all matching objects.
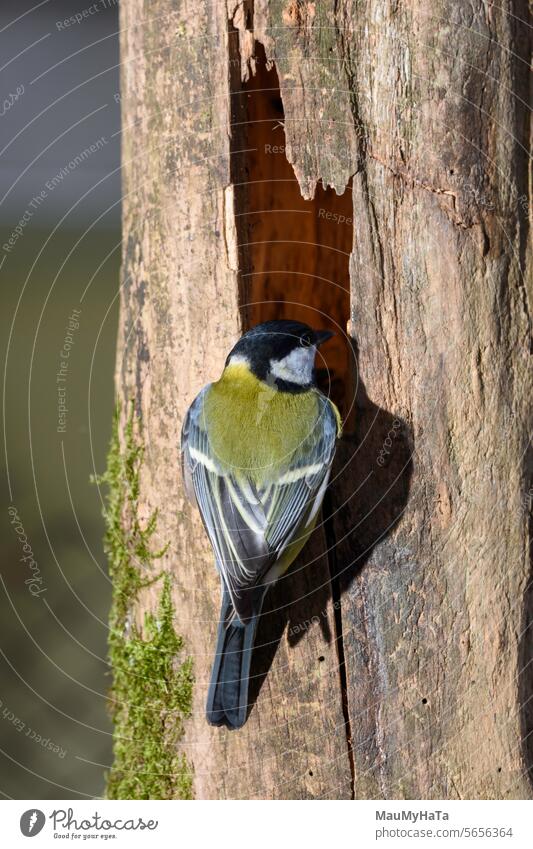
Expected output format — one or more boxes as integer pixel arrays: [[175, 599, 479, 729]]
[[226, 320, 333, 392]]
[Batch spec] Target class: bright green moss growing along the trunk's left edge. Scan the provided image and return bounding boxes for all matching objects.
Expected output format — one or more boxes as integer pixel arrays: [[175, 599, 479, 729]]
[[98, 406, 193, 799]]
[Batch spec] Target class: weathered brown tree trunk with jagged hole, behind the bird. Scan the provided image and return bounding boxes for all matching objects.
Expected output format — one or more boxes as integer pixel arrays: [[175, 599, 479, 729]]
[[117, 0, 533, 799]]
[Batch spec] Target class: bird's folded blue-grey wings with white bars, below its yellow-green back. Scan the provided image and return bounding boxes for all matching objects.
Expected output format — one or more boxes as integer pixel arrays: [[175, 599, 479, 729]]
[[182, 387, 337, 622]]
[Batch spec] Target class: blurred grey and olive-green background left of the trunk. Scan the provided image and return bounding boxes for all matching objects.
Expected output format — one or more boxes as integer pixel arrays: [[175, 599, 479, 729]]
[[0, 0, 120, 799]]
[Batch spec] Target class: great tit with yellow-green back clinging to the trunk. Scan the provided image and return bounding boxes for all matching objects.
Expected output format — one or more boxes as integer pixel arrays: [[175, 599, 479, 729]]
[[181, 321, 341, 728]]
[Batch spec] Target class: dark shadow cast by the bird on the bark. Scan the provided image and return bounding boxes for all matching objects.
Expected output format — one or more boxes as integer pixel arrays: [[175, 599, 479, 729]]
[[249, 334, 413, 710]]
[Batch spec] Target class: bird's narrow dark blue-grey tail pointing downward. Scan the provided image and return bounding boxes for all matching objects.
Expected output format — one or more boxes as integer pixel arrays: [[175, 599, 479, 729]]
[[206, 590, 259, 728]]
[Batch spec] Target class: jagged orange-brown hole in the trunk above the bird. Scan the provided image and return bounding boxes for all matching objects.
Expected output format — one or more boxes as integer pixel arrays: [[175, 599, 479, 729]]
[[232, 45, 353, 413]]
